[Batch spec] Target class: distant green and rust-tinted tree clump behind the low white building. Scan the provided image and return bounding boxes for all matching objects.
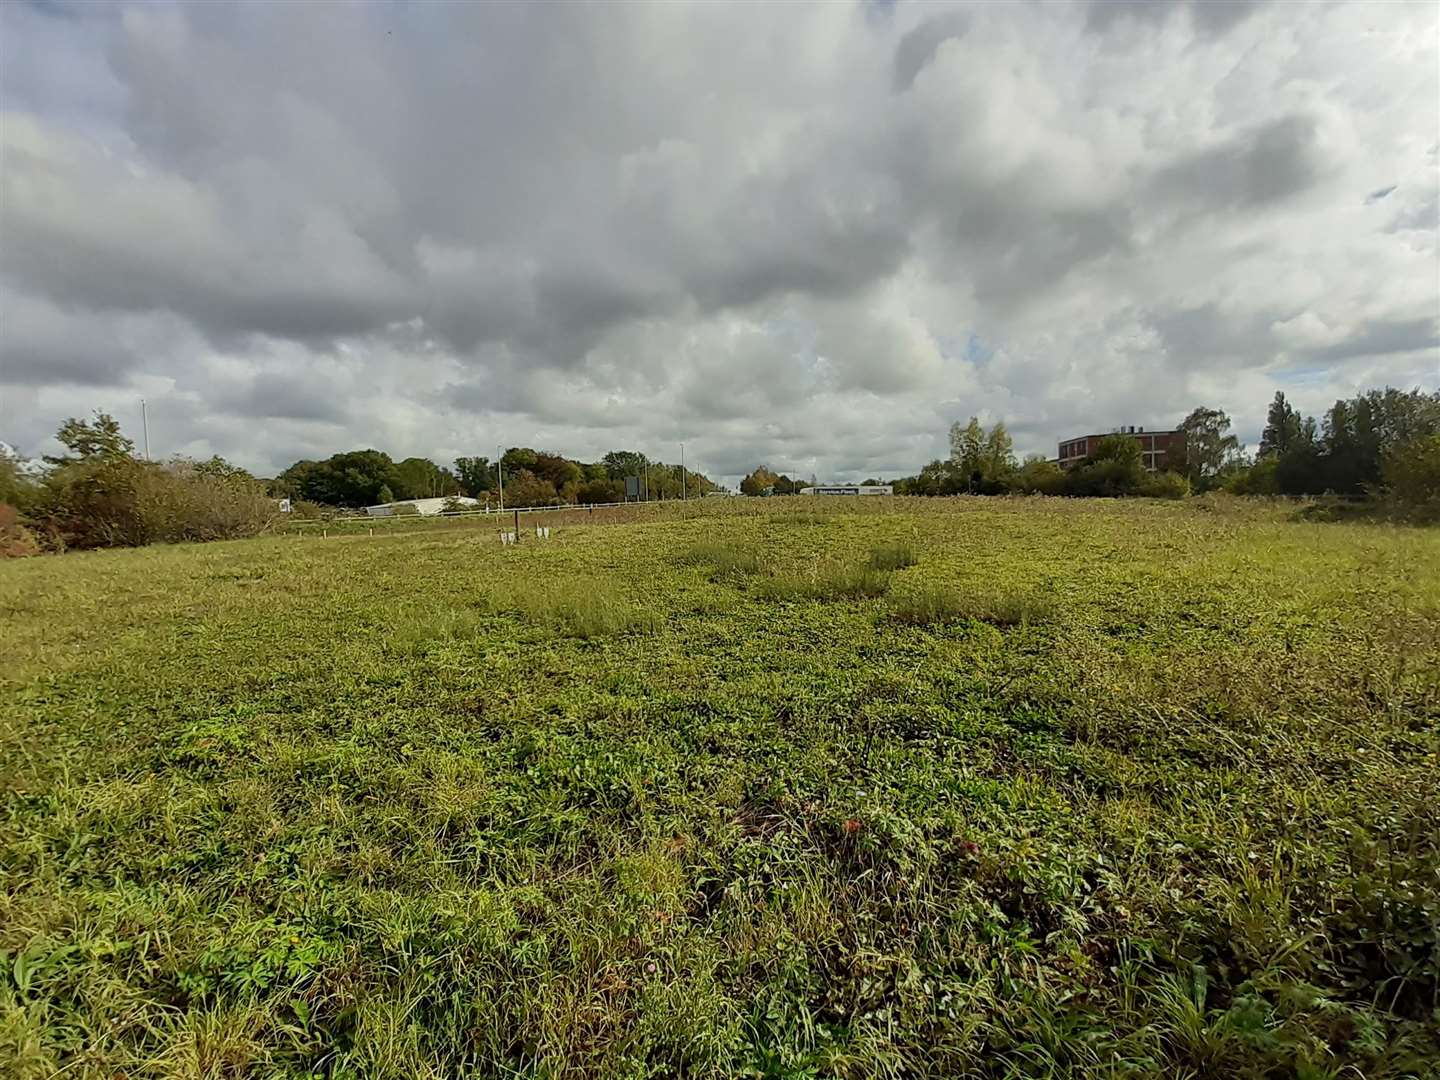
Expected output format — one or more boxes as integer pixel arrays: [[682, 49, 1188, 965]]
[[269, 446, 717, 508]]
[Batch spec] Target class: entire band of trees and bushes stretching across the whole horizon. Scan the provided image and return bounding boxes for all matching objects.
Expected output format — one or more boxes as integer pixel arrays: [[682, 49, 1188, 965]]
[[0, 387, 1440, 556]]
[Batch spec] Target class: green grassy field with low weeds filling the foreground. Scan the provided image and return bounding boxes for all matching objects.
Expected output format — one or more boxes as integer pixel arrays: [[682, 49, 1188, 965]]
[[0, 500, 1440, 1079]]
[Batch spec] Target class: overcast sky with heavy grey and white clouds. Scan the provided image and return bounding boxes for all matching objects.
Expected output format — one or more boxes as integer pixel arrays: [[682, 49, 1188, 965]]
[[0, 0, 1440, 480]]
